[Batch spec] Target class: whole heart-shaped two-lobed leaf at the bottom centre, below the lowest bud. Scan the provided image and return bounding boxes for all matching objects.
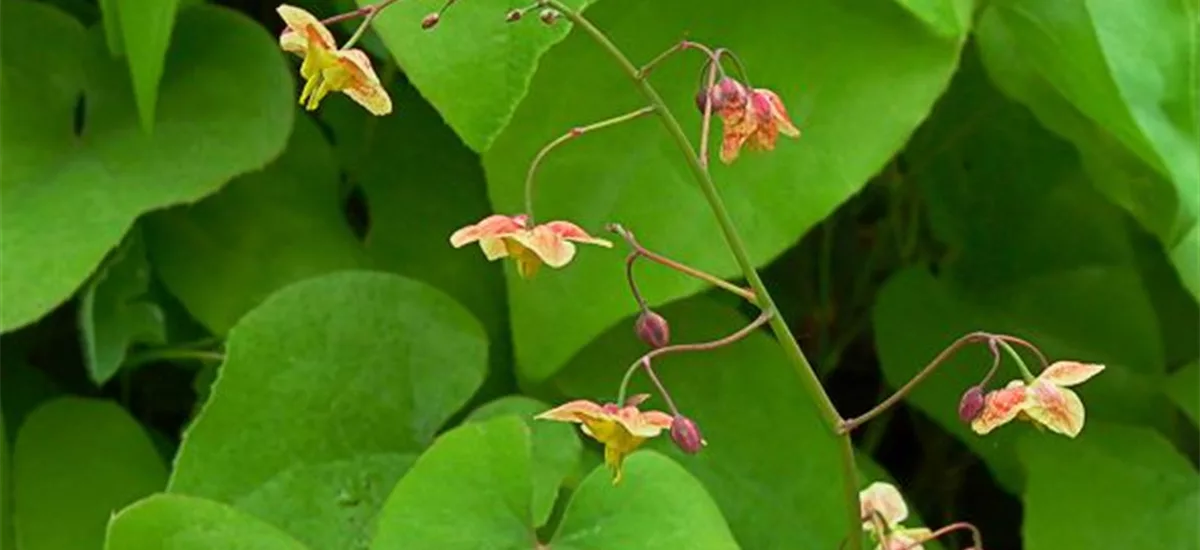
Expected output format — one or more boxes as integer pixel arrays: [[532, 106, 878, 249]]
[[371, 416, 738, 550]]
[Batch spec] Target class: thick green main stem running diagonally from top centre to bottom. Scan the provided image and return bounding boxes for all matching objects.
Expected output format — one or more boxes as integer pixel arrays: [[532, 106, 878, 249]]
[[542, 0, 863, 550]]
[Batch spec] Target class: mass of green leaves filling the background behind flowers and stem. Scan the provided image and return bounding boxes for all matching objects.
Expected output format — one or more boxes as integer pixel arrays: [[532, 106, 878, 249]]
[[0, 0, 1200, 550]]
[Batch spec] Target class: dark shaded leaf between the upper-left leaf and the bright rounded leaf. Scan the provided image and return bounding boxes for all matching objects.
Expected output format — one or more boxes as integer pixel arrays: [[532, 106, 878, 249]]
[[145, 116, 367, 334]]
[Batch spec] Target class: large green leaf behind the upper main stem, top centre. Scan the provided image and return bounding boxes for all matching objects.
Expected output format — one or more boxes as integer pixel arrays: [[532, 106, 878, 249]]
[[482, 0, 959, 381]]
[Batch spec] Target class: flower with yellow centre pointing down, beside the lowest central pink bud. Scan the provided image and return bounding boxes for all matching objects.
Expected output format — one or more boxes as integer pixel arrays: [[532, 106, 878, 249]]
[[536, 400, 672, 485]]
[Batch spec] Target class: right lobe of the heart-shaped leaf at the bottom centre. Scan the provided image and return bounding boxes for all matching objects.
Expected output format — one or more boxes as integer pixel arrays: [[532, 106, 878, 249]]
[[552, 450, 739, 550]]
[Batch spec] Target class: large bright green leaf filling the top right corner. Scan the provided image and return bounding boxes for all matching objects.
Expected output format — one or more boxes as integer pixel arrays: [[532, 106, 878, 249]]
[[979, 0, 1200, 298]]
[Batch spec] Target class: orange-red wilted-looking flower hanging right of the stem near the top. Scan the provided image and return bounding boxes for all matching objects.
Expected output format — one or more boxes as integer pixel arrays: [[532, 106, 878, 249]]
[[709, 77, 800, 165]]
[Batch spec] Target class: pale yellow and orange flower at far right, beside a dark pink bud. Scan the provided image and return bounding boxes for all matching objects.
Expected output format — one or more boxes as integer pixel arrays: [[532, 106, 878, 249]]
[[971, 361, 1104, 437]]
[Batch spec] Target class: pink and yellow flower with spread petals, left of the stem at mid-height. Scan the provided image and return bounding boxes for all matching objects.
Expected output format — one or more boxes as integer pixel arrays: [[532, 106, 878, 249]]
[[450, 214, 612, 279]]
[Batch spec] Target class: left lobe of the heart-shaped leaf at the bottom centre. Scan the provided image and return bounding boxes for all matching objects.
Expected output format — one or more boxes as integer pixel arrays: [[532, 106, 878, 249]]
[[371, 417, 534, 550]]
